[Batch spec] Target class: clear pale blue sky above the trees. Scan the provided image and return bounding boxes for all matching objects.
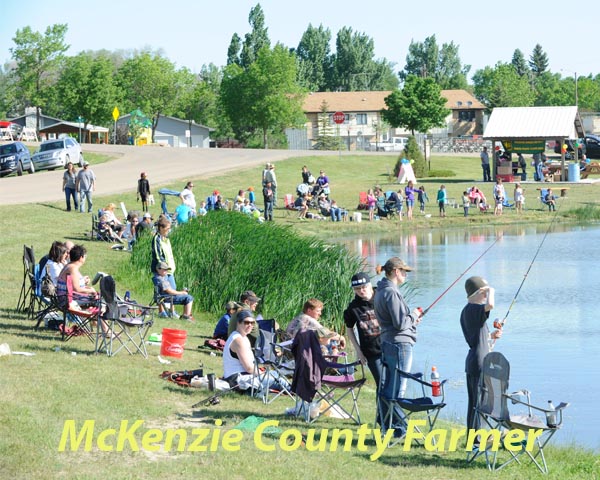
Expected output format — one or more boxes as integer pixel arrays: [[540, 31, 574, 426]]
[[0, 0, 600, 80]]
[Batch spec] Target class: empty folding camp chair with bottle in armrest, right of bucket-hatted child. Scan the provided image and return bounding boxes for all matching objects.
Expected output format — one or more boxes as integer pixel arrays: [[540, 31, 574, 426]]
[[467, 352, 569, 473]]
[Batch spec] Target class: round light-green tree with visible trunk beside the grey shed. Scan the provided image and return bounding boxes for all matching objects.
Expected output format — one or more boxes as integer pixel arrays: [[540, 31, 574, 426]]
[[116, 52, 177, 142]]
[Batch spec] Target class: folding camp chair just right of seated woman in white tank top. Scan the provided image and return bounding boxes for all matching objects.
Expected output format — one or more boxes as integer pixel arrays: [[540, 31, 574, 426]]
[[252, 319, 294, 404]]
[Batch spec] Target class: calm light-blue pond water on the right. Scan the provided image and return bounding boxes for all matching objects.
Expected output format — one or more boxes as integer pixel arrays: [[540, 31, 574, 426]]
[[342, 225, 600, 451]]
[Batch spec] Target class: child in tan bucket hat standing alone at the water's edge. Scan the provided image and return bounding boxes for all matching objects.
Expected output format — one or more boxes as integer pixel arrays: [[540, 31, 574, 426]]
[[460, 277, 502, 429]]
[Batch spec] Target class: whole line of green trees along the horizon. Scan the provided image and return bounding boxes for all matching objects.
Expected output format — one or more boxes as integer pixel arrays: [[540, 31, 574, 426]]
[[0, 4, 600, 148]]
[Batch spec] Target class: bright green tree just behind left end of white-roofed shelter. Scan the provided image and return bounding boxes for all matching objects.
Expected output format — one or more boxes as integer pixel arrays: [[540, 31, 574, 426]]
[[473, 63, 535, 111]]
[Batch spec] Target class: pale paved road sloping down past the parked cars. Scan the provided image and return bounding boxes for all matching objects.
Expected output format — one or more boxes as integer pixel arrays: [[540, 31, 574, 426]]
[[0, 144, 346, 205]]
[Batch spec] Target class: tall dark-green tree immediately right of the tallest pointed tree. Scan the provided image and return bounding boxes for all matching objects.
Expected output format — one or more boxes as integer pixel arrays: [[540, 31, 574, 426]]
[[295, 24, 332, 92]]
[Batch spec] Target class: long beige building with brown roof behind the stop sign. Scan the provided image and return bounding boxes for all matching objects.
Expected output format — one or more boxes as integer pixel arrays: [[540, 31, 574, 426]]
[[303, 90, 485, 150]]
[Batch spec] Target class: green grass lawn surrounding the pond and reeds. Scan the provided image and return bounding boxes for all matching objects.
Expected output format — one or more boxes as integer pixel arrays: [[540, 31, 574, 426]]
[[0, 149, 600, 479]]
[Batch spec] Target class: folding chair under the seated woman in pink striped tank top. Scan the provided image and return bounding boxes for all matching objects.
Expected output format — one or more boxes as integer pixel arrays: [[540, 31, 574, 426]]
[[57, 275, 100, 343]]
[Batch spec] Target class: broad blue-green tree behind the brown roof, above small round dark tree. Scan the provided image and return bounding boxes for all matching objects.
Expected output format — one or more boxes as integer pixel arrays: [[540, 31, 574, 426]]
[[399, 35, 471, 89]]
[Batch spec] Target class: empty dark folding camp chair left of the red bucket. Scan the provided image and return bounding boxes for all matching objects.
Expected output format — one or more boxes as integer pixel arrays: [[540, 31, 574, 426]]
[[96, 275, 156, 358]]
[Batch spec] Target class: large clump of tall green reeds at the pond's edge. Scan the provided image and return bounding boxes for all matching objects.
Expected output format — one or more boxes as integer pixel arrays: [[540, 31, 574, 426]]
[[120, 212, 363, 329]]
